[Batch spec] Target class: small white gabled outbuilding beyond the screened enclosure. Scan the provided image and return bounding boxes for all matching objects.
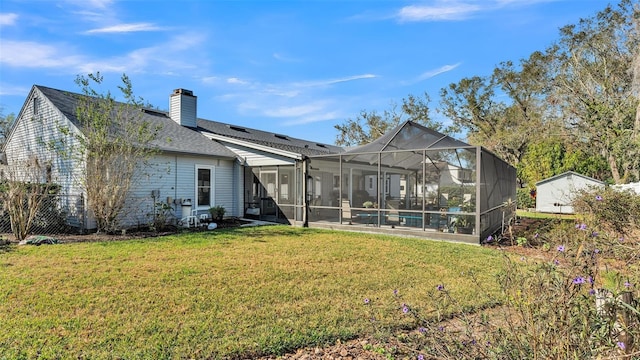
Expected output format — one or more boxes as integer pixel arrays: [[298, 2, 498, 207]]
[[536, 171, 605, 214]]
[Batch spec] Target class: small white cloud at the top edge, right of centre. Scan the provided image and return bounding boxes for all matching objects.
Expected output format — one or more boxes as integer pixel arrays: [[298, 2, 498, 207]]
[[396, 3, 481, 22]]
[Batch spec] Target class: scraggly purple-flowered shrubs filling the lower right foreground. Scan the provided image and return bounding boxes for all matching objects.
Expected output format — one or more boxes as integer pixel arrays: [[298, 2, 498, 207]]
[[367, 211, 640, 359]]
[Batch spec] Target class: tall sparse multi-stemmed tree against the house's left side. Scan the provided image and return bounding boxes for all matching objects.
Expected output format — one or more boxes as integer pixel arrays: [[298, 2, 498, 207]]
[[56, 73, 160, 232]]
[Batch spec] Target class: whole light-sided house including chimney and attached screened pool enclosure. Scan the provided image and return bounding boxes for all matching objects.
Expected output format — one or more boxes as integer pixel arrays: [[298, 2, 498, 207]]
[[3, 86, 516, 244]]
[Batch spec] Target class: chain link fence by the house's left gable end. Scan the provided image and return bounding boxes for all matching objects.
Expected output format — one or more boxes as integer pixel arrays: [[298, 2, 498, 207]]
[[0, 195, 86, 235]]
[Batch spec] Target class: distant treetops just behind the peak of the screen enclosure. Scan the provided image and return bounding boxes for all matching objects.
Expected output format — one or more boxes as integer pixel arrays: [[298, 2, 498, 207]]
[[334, 92, 448, 146]]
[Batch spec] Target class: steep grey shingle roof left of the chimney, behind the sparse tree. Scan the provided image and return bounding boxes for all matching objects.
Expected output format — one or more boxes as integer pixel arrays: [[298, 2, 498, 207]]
[[35, 85, 236, 158]]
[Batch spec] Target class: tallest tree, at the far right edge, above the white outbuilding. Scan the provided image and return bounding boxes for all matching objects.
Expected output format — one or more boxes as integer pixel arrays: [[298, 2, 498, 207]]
[[548, 0, 640, 183]]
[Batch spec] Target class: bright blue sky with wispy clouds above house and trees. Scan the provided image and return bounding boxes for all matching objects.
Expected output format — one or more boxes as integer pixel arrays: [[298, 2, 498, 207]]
[[0, 0, 608, 143]]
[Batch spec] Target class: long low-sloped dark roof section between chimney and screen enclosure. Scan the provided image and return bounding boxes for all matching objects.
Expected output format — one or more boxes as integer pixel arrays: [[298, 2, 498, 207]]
[[198, 119, 344, 156]]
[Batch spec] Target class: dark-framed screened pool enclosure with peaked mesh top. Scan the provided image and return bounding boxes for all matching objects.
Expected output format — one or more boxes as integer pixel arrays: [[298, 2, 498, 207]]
[[304, 122, 516, 243]]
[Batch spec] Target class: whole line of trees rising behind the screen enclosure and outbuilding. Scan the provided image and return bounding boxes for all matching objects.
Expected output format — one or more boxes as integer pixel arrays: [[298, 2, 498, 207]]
[[335, 0, 640, 187]]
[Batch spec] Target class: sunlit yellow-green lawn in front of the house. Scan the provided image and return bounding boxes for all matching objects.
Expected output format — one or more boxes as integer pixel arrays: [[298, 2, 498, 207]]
[[0, 226, 502, 359]]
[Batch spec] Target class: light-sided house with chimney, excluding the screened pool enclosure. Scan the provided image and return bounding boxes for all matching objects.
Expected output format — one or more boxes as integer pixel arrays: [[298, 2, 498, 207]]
[[3, 85, 341, 229]]
